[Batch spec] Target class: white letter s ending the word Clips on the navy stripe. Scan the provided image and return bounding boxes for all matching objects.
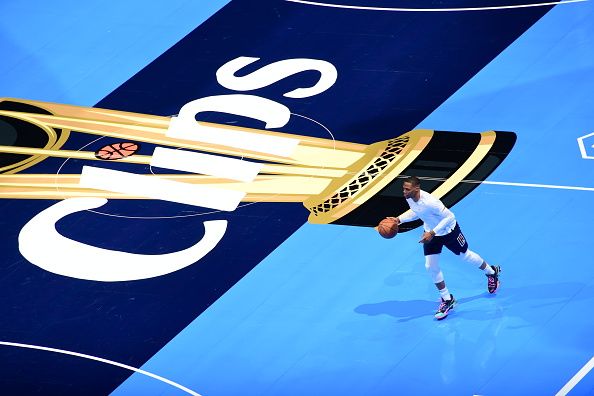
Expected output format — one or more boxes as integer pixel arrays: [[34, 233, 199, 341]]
[[217, 56, 338, 99]]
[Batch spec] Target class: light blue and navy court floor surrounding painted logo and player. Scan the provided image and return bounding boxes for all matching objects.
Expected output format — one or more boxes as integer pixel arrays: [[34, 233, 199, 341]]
[[0, 0, 594, 396]]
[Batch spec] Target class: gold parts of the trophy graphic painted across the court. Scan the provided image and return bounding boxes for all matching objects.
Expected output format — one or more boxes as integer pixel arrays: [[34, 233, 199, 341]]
[[0, 98, 507, 223]]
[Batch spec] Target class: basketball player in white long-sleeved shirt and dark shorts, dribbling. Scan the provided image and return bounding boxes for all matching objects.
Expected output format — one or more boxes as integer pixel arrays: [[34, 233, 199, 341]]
[[389, 176, 501, 320]]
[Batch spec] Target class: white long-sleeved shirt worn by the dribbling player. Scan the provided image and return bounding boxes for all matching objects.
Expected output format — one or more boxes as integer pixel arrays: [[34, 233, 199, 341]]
[[399, 190, 456, 236]]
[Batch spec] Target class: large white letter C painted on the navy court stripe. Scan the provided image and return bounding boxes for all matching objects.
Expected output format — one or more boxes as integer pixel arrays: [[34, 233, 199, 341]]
[[19, 198, 227, 282]]
